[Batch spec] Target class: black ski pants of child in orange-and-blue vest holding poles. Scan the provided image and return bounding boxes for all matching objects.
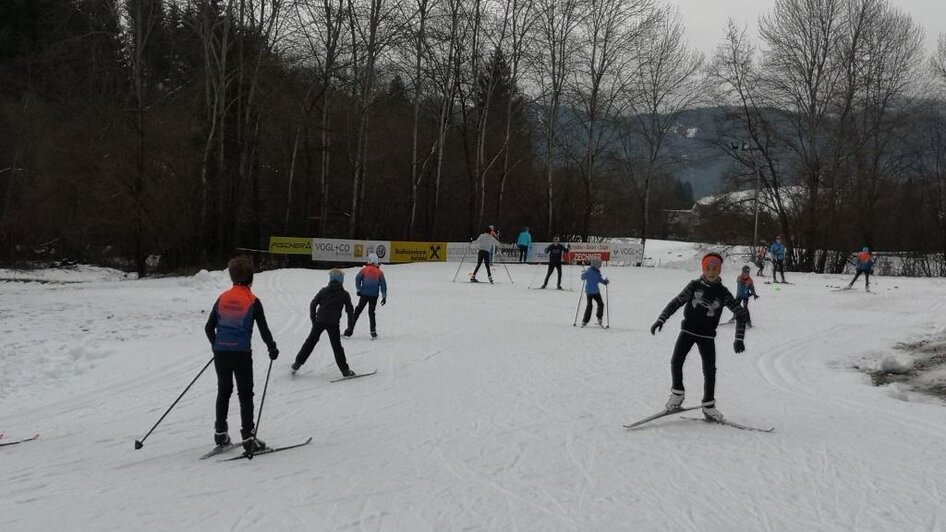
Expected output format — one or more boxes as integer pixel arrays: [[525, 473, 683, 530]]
[[214, 351, 253, 438]]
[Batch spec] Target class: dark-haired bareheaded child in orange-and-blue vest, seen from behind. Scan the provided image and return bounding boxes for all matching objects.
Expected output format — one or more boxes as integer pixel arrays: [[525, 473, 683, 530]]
[[204, 257, 279, 453]]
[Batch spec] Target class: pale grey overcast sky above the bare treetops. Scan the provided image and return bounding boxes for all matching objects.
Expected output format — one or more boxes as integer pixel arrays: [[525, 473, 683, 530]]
[[663, 0, 946, 58]]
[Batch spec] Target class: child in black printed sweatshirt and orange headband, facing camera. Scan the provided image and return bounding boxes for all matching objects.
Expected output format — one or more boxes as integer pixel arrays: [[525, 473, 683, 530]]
[[650, 253, 746, 421]]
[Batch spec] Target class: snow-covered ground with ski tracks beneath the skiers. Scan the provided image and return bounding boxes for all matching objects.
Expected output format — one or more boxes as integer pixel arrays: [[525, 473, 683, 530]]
[[0, 242, 946, 531]]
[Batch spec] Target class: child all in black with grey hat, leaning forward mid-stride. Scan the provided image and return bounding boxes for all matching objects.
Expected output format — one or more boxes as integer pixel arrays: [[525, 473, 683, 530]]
[[292, 268, 355, 377]]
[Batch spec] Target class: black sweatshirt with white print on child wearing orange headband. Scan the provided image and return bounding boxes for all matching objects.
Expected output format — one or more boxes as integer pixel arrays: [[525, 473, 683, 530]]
[[657, 277, 746, 340]]
